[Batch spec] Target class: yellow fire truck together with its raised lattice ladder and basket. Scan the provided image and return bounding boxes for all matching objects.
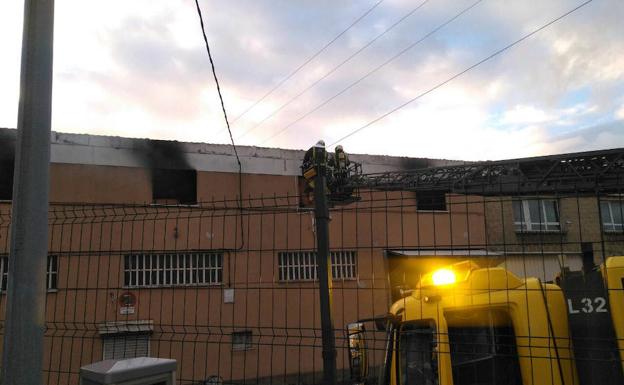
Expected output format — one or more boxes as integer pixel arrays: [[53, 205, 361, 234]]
[[302, 143, 624, 385]]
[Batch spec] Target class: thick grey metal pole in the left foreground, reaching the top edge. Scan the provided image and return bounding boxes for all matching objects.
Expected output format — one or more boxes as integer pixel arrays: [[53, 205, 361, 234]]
[[2, 0, 54, 385]]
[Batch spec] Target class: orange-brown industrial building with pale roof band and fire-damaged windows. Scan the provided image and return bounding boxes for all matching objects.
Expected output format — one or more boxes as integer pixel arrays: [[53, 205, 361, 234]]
[[0, 129, 624, 384]]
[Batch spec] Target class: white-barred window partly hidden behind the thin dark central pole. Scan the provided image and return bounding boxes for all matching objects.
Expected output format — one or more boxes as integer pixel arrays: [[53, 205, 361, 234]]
[[278, 250, 357, 281]]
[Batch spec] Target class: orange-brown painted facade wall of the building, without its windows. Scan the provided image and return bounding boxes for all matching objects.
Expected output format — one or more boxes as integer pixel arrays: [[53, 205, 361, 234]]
[[0, 164, 485, 384]]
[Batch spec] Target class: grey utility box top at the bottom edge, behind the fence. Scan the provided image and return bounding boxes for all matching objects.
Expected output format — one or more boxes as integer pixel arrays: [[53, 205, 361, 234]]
[[80, 357, 177, 385]]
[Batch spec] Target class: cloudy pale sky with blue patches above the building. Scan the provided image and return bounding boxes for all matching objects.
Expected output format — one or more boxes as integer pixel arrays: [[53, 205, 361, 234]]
[[0, 0, 624, 160]]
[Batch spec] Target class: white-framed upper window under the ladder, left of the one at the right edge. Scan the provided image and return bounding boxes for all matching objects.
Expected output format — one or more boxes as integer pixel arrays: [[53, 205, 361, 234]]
[[512, 197, 563, 233]]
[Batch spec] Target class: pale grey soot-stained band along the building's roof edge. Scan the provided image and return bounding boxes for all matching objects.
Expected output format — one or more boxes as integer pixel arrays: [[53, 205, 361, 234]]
[[0, 128, 463, 175]]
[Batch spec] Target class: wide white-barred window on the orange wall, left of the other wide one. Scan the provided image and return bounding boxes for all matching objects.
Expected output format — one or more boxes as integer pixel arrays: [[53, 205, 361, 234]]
[[124, 253, 223, 287]]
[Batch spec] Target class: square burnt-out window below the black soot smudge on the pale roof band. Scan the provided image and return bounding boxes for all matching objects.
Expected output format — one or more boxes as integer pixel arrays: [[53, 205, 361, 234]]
[[152, 169, 197, 205]]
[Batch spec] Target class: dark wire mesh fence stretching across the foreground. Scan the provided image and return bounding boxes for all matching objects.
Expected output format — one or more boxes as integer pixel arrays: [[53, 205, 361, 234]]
[[0, 185, 624, 385]]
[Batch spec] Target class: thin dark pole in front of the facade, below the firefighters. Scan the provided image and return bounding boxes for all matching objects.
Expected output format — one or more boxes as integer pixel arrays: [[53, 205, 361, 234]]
[[313, 142, 336, 385]]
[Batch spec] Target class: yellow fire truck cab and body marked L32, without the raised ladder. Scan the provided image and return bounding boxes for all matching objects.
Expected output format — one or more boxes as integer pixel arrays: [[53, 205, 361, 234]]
[[347, 257, 624, 385]]
